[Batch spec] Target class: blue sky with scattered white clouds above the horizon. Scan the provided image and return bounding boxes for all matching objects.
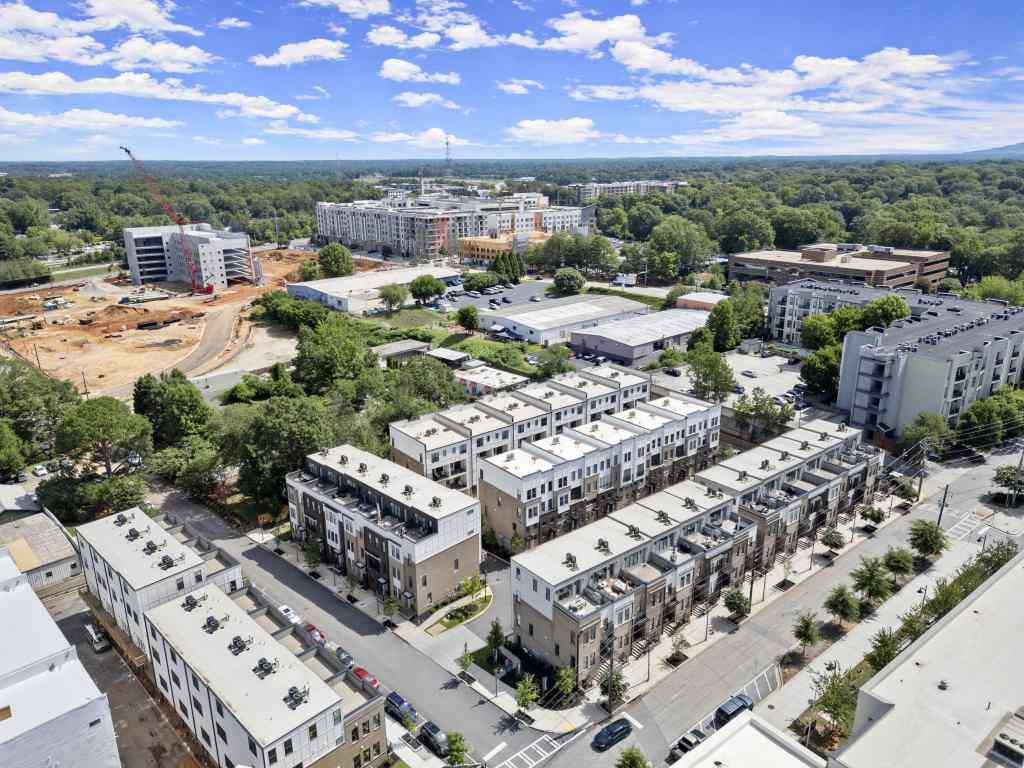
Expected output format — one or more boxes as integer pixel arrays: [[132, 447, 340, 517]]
[[0, 0, 1024, 161]]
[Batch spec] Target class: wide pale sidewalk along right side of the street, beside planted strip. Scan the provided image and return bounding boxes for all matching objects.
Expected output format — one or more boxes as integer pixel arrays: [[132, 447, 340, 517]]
[[758, 541, 978, 730]]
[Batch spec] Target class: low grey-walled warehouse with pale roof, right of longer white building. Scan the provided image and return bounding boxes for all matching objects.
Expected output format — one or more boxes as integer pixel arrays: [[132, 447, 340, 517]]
[[569, 309, 709, 366]]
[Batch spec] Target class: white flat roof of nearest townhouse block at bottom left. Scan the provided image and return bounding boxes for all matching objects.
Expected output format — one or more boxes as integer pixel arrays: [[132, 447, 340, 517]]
[[145, 584, 341, 746]]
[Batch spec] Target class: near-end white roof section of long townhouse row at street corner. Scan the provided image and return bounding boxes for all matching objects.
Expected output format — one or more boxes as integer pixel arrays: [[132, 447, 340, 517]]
[[512, 517, 647, 586]]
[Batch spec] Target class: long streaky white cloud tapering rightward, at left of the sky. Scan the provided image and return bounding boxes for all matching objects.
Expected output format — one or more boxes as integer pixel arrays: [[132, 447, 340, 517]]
[[0, 72, 316, 122]]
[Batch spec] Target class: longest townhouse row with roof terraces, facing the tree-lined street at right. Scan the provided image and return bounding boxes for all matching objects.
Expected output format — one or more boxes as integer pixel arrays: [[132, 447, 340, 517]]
[[512, 421, 881, 681]]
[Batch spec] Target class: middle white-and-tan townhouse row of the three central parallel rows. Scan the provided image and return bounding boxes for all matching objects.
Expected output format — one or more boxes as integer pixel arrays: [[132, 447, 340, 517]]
[[478, 397, 720, 551]]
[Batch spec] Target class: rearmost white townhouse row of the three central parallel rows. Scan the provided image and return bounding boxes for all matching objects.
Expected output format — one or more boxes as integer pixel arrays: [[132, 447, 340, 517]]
[[389, 366, 650, 494]]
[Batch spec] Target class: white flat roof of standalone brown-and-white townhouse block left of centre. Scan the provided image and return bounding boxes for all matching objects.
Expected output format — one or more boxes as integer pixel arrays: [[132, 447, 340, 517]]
[[309, 444, 477, 519]]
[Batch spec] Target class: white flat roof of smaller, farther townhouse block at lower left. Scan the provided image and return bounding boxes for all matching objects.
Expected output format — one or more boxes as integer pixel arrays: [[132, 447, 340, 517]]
[[77, 507, 203, 591]]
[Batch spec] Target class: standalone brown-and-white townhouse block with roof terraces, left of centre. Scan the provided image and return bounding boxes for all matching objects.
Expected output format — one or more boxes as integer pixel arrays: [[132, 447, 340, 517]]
[[287, 444, 481, 616]]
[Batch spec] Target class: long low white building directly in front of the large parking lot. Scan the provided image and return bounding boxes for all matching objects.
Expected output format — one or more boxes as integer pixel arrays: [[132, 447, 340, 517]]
[[480, 294, 650, 344]]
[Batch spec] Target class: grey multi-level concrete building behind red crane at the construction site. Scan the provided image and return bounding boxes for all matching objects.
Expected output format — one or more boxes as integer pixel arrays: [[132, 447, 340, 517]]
[[124, 223, 262, 289]]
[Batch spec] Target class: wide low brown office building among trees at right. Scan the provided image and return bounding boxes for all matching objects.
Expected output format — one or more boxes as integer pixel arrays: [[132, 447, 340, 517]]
[[729, 243, 949, 290]]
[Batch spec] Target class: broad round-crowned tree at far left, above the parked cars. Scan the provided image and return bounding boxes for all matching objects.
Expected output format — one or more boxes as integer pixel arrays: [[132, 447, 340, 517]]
[[56, 396, 153, 476]]
